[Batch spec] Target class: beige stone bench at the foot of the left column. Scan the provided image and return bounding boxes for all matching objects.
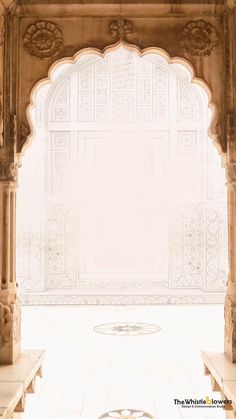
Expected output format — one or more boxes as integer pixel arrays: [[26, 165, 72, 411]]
[[0, 351, 44, 419]]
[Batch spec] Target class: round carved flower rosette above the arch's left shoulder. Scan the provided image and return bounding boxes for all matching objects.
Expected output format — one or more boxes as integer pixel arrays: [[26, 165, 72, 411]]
[[23, 20, 64, 59]]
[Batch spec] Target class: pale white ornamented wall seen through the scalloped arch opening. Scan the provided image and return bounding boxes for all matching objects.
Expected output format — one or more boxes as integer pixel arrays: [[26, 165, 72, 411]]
[[17, 47, 227, 303]]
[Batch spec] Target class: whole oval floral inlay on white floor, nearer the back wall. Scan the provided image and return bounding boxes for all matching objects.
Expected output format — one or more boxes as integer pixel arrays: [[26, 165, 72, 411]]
[[94, 322, 161, 336]]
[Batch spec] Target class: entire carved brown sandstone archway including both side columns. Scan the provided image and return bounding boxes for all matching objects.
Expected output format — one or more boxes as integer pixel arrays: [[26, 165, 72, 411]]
[[0, 0, 236, 416]]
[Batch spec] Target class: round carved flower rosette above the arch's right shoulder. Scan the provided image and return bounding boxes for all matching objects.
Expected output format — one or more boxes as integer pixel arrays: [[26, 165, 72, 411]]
[[180, 20, 219, 57]]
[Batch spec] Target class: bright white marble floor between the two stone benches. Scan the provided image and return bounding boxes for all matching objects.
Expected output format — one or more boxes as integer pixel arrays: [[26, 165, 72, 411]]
[[22, 305, 225, 419]]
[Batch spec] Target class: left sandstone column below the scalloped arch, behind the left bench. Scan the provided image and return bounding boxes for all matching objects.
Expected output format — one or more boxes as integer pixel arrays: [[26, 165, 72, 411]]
[[0, 160, 21, 364]]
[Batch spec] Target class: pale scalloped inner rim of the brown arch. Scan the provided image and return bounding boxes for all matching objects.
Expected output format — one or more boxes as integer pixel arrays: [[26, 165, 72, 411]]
[[19, 40, 224, 158]]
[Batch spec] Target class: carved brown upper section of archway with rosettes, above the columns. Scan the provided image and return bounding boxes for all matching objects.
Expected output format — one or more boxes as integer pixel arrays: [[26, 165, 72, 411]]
[[0, 1, 235, 306]]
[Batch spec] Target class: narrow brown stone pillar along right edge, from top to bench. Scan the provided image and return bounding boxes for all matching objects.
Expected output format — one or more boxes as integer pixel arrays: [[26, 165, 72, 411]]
[[222, 0, 236, 362]]
